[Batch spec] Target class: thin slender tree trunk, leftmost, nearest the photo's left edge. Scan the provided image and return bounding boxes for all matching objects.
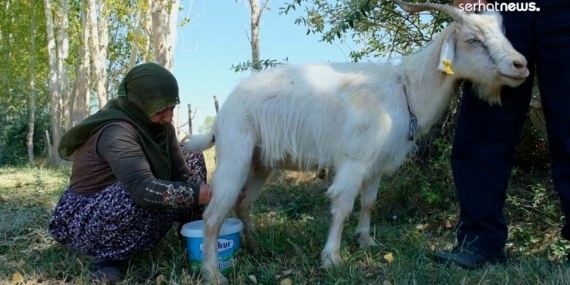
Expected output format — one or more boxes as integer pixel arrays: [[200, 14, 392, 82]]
[[26, 0, 36, 163]]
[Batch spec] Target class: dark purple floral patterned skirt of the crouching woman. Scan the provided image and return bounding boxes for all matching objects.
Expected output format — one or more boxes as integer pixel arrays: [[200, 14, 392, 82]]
[[49, 146, 207, 260]]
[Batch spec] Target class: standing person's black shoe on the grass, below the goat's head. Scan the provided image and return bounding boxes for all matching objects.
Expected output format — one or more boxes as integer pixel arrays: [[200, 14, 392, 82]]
[[434, 245, 507, 269]]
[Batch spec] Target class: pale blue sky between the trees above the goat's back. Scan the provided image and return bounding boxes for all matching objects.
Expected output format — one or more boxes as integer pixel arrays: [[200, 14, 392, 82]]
[[169, 0, 359, 133]]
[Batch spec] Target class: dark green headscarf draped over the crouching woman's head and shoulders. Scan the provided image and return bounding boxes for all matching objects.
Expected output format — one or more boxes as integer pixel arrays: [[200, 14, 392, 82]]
[[58, 63, 180, 179]]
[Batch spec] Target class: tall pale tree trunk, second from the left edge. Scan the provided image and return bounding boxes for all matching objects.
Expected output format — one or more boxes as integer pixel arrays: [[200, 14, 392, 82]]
[[44, 0, 61, 165]]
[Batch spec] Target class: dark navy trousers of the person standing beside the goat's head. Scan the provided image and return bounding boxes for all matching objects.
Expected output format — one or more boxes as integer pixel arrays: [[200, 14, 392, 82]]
[[451, 0, 570, 251]]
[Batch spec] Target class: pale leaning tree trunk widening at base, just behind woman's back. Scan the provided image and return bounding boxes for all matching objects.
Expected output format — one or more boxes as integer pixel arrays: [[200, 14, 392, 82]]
[[71, 0, 91, 127]]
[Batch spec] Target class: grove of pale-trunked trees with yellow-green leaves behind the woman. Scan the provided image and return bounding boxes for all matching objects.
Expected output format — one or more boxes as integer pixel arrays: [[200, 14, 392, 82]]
[[0, 0, 166, 164]]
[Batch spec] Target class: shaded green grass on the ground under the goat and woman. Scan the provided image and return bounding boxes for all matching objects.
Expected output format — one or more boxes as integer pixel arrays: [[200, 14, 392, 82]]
[[0, 144, 570, 285]]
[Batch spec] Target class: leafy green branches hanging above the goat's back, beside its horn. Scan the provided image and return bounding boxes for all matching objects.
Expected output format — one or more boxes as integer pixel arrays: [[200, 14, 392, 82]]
[[279, 0, 451, 61]]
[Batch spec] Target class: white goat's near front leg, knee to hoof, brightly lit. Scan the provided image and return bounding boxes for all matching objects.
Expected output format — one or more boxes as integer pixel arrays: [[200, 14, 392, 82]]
[[321, 162, 364, 267]]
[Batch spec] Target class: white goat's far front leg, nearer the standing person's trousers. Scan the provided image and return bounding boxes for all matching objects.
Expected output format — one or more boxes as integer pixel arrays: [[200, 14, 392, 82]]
[[356, 176, 380, 248]]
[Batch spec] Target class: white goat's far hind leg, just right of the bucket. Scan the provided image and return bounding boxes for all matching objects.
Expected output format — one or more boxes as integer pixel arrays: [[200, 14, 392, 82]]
[[236, 168, 271, 252]]
